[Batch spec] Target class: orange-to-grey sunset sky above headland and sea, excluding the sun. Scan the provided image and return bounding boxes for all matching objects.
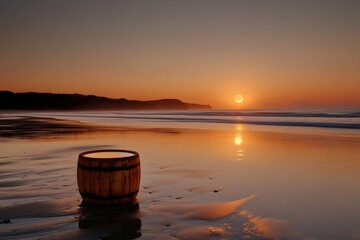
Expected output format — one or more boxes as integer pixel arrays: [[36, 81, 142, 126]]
[[0, 0, 360, 109]]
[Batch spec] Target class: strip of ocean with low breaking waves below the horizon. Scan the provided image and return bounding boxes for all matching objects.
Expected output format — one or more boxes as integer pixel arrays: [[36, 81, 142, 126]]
[[22, 109, 360, 129]]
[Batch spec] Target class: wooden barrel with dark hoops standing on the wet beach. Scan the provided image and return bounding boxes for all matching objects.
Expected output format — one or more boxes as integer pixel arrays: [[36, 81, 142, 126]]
[[77, 149, 141, 205]]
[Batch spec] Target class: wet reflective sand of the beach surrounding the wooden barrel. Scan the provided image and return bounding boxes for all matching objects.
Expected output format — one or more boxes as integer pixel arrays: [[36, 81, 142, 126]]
[[0, 116, 360, 239]]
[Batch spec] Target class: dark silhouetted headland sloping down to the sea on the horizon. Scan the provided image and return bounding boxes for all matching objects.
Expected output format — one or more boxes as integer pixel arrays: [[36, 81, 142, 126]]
[[0, 91, 211, 110]]
